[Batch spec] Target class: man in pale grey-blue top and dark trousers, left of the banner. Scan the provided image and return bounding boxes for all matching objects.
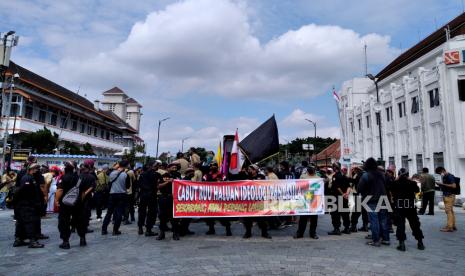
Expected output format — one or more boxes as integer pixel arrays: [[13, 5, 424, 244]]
[[102, 160, 131, 236]]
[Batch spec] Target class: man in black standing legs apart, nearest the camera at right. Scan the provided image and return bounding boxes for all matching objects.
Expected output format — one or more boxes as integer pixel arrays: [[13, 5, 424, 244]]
[[391, 168, 425, 251]]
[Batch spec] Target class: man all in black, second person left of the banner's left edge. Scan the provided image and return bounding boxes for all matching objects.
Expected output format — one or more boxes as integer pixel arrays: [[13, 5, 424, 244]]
[[138, 163, 163, 237]]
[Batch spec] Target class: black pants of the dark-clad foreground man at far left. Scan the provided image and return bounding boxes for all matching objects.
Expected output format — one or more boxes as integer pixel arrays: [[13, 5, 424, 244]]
[[15, 205, 41, 241]]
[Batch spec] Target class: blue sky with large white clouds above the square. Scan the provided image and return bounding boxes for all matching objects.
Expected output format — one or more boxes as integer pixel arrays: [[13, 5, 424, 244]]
[[0, 0, 463, 154]]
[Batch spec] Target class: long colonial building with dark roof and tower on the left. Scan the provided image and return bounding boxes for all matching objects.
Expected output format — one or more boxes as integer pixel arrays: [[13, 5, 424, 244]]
[[0, 62, 143, 157]]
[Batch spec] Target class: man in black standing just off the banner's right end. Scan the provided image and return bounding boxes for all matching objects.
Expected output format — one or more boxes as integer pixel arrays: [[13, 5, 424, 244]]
[[328, 163, 350, 235]]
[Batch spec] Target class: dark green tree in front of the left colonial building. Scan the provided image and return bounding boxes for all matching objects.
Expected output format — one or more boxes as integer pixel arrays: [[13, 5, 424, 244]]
[[20, 127, 58, 154]]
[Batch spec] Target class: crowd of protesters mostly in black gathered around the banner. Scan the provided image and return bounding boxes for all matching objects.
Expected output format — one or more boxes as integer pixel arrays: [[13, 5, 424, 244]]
[[0, 148, 458, 251]]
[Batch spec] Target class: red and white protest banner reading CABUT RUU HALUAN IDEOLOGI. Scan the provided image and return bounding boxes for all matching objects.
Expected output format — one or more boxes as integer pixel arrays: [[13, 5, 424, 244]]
[[173, 178, 325, 218]]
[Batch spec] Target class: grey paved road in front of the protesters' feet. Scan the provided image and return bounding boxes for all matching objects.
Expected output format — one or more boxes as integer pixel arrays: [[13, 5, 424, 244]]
[[0, 208, 465, 275]]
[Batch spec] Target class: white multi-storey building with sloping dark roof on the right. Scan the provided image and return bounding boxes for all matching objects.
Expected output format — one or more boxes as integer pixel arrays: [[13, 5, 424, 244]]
[[339, 13, 465, 201]]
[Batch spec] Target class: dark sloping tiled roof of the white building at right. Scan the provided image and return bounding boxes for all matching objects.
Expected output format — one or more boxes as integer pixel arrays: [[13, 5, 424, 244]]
[[376, 13, 465, 80]]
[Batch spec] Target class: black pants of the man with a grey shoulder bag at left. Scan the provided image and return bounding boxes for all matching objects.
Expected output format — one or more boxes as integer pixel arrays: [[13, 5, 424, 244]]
[[58, 204, 89, 241]]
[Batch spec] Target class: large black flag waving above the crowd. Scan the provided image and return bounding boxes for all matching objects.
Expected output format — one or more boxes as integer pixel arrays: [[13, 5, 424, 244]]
[[239, 115, 279, 163]]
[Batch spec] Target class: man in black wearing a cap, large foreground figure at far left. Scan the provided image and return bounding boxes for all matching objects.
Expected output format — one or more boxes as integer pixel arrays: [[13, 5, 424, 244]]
[[13, 163, 44, 248]]
